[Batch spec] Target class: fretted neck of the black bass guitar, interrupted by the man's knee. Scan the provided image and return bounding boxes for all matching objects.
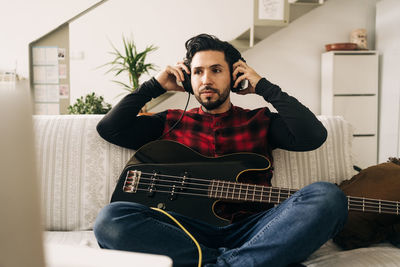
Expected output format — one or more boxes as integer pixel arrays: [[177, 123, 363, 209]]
[[208, 180, 400, 215]]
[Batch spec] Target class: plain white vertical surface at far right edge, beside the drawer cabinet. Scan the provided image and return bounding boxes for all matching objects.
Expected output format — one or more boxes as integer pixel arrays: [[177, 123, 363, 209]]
[[376, 0, 400, 162]]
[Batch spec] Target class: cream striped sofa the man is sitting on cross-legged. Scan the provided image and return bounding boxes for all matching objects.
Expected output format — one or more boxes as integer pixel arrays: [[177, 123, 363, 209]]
[[33, 115, 400, 267]]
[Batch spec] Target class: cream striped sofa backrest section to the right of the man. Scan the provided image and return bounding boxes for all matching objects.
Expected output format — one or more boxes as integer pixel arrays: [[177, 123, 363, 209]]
[[272, 116, 355, 189]]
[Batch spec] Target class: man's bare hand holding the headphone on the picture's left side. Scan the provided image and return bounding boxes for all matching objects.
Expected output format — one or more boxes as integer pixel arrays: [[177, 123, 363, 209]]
[[156, 61, 190, 92]]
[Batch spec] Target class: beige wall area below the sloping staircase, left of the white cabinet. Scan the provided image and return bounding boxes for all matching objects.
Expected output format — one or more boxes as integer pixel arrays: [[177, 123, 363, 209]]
[[244, 0, 377, 114]]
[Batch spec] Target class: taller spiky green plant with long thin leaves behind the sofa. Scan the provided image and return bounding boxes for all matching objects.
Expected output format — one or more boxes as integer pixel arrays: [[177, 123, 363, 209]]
[[103, 36, 157, 112]]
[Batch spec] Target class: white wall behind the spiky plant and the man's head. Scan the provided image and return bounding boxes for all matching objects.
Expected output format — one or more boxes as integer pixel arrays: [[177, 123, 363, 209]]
[[70, 0, 252, 107]]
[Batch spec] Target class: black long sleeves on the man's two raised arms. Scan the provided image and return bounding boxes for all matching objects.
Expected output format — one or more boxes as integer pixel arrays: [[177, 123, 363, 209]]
[[97, 78, 327, 155]]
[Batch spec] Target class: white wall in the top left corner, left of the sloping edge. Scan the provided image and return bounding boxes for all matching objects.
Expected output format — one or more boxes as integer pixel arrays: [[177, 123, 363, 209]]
[[0, 0, 99, 77]]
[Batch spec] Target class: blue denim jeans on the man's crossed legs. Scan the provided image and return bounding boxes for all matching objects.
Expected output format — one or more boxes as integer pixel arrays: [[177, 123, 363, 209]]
[[94, 182, 347, 267]]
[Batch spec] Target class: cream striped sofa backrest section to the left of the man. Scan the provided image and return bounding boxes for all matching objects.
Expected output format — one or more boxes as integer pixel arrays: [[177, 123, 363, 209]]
[[34, 115, 133, 231]]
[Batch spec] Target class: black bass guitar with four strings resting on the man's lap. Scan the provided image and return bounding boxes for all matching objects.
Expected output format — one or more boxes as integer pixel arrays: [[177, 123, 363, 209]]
[[111, 140, 400, 226]]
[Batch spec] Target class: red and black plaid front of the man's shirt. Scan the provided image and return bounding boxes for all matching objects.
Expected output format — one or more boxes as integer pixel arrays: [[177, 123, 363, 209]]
[[164, 106, 271, 159]]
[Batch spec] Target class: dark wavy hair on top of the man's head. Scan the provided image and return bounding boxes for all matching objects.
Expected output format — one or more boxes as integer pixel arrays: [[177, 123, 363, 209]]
[[185, 33, 244, 73]]
